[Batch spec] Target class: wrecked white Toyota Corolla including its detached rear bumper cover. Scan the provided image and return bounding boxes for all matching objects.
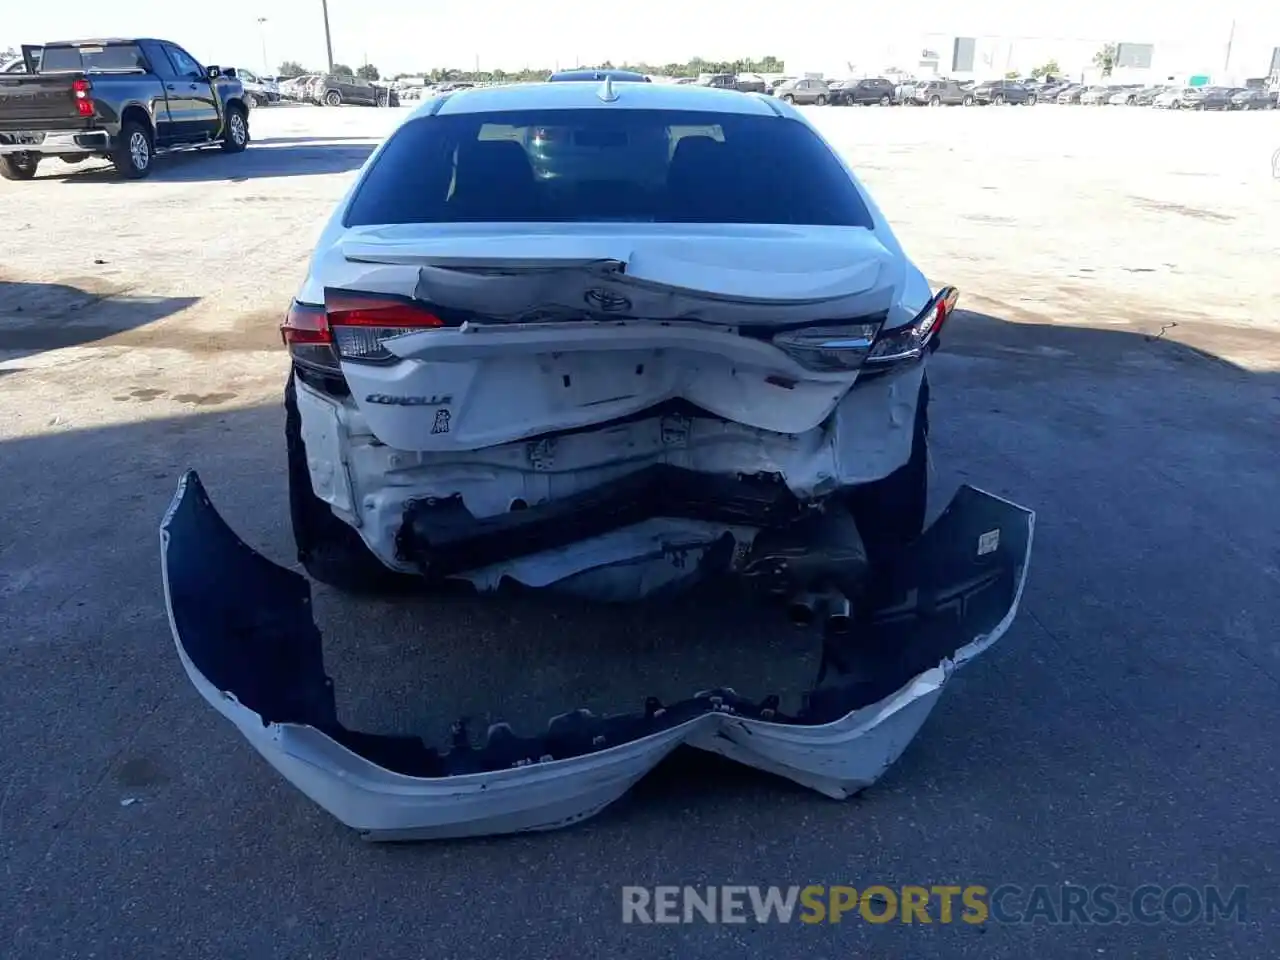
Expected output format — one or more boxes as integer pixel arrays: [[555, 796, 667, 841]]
[[161, 81, 1033, 838]]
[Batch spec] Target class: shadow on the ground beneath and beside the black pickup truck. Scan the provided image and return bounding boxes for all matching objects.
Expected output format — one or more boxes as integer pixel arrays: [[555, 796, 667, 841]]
[[41, 137, 378, 184]]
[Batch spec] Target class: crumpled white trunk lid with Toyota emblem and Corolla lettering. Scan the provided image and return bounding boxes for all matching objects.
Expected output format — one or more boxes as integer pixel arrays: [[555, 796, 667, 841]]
[[324, 224, 902, 451]]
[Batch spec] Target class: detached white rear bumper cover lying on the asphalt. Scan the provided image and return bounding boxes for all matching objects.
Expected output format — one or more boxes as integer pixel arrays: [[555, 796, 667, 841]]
[[160, 471, 1034, 840]]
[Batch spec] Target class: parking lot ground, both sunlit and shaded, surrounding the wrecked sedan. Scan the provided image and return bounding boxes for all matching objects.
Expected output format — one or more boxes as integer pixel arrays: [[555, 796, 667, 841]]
[[0, 106, 1280, 960]]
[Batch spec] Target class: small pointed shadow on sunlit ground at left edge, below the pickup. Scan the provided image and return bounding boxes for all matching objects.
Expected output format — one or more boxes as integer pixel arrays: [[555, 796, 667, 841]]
[[0, 280, 200, 361]]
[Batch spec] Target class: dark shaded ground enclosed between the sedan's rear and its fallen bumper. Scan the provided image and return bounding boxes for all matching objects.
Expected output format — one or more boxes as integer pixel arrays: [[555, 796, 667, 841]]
[[312, 584, 822, 746]]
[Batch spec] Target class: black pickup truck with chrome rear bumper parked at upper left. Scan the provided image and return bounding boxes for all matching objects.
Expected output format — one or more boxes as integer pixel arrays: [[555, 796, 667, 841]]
[[0, 38, 250, 180]]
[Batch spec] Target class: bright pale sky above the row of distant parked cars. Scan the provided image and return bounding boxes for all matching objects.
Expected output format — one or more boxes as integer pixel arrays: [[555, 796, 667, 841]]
[[0, 0, 1280, 73]]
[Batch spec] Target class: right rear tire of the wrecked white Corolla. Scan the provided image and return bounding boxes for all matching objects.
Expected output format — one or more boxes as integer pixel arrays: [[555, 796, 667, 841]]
[[845, 376, 929, 570]]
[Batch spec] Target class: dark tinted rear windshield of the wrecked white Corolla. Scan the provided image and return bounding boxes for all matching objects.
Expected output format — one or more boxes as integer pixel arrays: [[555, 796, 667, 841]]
[[346, 109, 872, 228]]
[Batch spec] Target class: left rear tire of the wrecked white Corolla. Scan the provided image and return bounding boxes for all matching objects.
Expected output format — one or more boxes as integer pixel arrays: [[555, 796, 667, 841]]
[[284, 374, 422, 595]]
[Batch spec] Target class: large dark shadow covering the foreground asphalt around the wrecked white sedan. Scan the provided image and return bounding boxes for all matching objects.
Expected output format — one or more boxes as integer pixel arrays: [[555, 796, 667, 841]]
[[0, 314, 1280, 960]]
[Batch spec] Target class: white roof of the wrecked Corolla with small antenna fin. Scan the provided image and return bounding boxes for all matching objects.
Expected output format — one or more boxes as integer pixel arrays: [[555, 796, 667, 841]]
[[412, 81, 782, 116]]
